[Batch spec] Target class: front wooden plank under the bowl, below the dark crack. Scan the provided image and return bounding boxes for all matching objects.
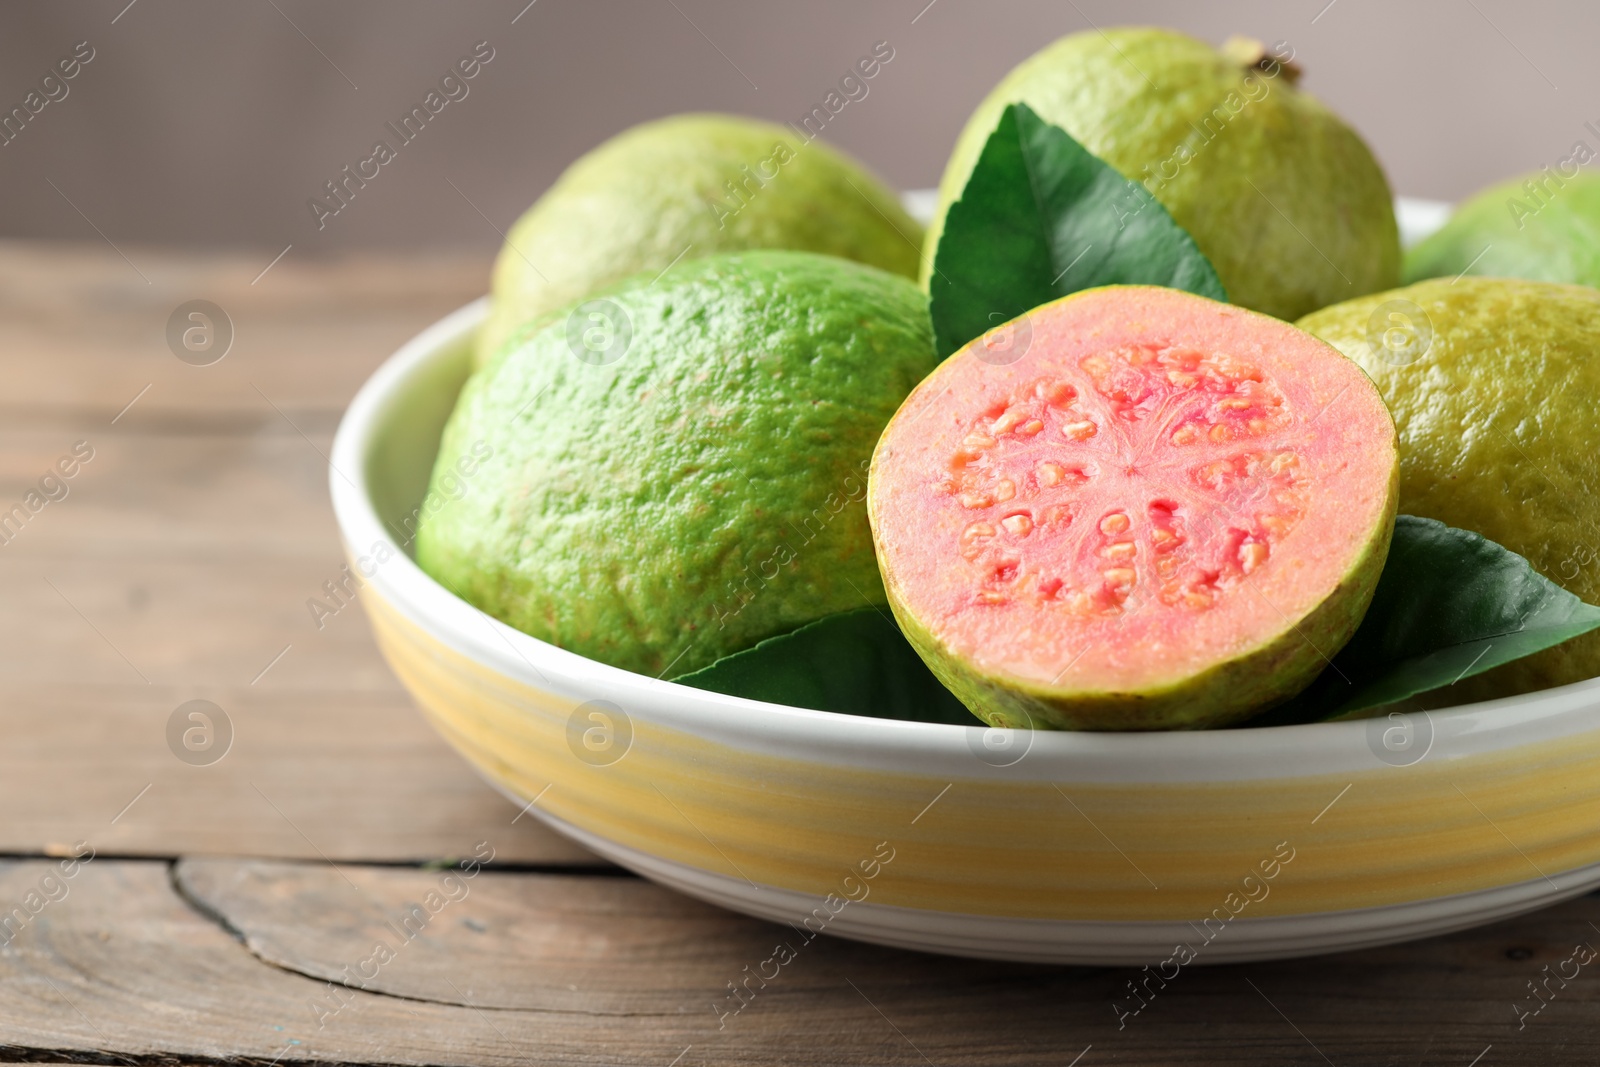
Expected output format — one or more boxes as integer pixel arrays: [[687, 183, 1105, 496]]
[[0, 861, 1600, 1067]]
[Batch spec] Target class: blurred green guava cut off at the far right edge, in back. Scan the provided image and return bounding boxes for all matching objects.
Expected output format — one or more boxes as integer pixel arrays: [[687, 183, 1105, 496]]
[[1405, 173, 1600, 286]]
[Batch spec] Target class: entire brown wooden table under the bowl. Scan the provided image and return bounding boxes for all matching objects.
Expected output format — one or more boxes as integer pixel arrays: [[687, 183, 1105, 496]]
[[0, 245, 1600, 1067]]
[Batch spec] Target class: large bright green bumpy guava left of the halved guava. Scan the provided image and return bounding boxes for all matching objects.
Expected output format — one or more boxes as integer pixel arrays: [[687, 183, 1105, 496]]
[[416, 251, 936, 677]]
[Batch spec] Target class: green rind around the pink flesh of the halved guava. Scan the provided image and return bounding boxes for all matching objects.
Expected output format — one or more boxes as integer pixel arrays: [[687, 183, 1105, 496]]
[[867, 286, 1400, 731]]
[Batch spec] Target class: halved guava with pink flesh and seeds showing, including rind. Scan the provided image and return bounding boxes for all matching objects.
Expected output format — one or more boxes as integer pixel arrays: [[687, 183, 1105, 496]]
[[867, 286, 1398, 729]]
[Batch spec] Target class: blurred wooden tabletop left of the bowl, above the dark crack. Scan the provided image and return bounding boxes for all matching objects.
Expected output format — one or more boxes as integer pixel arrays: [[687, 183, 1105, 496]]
[[0, 243, 598, 865]]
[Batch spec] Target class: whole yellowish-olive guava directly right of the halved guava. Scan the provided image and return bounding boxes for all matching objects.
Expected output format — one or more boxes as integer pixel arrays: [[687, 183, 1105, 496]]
[[1298, 277, 1600, 702]]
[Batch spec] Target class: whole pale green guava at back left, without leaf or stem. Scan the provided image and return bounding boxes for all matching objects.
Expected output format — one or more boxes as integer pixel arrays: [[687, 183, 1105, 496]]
[[477, 114, 922, 365]]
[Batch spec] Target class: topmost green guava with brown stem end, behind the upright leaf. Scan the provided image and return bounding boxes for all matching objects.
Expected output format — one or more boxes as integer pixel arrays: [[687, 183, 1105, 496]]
[[922, 27, 1400, 320]]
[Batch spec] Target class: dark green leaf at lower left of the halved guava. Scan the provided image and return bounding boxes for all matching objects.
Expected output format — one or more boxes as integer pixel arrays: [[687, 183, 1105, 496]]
[[674, 608, 982, 726]]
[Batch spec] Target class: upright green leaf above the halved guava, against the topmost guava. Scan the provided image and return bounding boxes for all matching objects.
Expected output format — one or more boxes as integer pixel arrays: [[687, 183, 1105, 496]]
[[928, 104, 1227, 358]]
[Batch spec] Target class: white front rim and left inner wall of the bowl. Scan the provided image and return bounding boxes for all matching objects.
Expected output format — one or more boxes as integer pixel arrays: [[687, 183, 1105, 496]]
[[330, 275, 1600, 790]]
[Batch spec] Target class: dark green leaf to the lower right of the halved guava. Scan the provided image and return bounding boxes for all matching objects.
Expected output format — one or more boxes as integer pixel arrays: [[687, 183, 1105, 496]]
[[1243, 515, 1600, 726]]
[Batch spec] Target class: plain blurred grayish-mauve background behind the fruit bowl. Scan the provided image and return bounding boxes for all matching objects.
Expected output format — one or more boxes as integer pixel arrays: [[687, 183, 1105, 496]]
[[0, 0, 1600, 254]]
